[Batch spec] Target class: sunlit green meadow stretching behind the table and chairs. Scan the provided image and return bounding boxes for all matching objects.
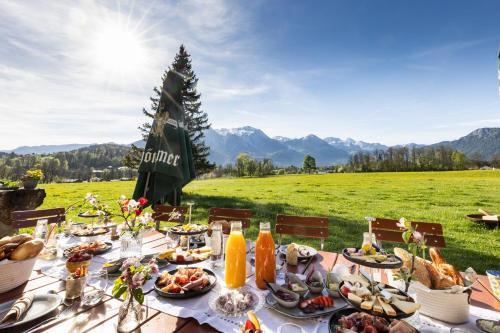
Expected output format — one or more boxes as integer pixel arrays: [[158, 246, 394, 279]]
[[40, 171, 500, 274]]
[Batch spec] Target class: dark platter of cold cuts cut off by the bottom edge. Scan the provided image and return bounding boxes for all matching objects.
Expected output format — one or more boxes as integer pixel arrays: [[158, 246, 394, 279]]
[[328, 308, 418, 333]]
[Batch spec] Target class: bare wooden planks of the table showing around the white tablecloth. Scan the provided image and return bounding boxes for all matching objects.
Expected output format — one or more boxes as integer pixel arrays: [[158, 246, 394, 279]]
[[0, 232, 500, 333]]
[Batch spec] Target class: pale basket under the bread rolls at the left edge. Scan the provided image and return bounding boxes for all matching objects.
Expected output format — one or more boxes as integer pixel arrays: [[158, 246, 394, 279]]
[[0, 257, 37, 293]]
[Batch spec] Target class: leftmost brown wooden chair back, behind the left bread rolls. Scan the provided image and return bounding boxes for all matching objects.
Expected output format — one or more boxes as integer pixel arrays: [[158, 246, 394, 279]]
[[10, 208, 66, 230]]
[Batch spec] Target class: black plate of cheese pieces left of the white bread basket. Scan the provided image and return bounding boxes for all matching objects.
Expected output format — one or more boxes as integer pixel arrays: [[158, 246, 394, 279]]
[[339, 275, 420, 319]]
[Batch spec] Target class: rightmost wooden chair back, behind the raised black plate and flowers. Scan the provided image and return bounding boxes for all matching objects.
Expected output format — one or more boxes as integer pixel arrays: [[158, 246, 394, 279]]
[[372, 217, 446, 247]]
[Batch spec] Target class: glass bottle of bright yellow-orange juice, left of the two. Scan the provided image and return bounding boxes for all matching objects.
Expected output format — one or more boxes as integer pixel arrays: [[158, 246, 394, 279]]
[[224, 222, 247, 288]]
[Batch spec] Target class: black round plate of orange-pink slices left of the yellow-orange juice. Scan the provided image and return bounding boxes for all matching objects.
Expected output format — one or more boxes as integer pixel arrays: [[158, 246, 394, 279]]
[[155, 267, 217, 298]]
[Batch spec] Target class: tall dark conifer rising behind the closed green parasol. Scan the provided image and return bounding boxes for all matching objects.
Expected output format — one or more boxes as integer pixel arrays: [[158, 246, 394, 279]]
[[124, 45, 215, 175]]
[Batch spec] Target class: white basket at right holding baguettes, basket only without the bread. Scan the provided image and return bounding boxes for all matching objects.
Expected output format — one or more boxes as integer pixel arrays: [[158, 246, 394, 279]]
[[412, 283, 469, 324]]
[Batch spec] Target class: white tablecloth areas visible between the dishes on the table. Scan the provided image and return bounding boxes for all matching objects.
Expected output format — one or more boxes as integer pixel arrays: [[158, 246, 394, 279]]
[[35, 238, 500, 333]]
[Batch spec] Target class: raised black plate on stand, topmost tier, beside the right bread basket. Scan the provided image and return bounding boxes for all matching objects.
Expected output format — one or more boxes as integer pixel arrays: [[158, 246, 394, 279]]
[[342, 245, 403, 269]]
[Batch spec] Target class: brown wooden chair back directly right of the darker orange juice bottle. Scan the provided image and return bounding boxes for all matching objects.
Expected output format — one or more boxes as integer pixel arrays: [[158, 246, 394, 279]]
[[275, 214, 329, 250]]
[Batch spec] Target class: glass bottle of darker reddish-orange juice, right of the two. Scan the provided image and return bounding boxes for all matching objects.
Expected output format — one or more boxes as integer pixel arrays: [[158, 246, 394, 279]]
[[255, 222, 276, 289]]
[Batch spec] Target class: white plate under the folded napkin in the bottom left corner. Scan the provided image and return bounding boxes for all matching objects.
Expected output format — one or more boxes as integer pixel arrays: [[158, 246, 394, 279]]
[[0, 294, 62, 329]]
